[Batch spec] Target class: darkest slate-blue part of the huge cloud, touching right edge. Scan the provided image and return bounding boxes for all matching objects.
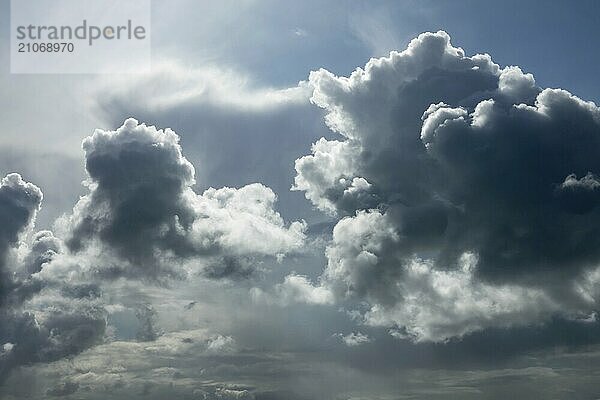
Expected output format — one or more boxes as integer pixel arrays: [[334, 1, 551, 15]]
[[423, 89, 600, 284]]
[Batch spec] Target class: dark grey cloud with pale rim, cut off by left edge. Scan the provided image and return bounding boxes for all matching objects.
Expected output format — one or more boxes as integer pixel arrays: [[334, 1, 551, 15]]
[[0, 174, 105, 379]]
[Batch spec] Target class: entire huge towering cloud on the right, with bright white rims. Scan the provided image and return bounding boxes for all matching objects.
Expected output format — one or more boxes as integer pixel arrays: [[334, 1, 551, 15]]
[[288, 32, 600, 341]]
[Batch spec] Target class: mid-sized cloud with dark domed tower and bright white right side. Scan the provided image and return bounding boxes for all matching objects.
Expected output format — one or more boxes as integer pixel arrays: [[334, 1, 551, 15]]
[[62, 119, 305, 277]]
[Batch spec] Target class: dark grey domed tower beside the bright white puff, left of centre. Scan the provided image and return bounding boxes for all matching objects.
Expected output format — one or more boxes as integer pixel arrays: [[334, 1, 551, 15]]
[[67, 120, 194, 263]]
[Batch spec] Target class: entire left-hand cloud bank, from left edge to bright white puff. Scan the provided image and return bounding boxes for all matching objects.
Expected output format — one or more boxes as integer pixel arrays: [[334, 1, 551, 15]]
[[0, 119, 305, 379]]
